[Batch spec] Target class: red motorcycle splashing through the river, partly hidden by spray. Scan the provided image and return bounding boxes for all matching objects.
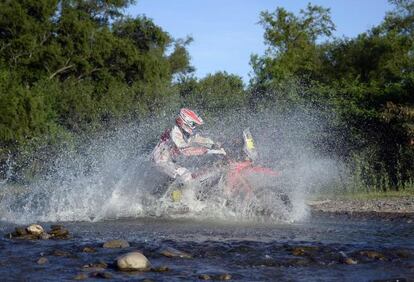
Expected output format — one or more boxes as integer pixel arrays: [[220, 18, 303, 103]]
[[156, 128, 293, 219]]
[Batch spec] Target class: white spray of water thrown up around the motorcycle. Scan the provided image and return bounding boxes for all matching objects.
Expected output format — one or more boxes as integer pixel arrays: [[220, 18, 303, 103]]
[[0, 107, 337, 223]]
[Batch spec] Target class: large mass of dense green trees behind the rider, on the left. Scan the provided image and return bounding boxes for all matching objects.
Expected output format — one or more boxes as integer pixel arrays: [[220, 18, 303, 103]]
[[0, 0, 193, 181]]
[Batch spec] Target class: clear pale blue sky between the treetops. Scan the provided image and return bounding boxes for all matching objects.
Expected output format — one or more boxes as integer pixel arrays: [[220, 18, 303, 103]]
[[127, 0, 392, 82]]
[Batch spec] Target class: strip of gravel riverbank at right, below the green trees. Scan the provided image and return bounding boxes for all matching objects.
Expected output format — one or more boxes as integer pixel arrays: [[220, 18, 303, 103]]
[[307, 194, 414, 221]]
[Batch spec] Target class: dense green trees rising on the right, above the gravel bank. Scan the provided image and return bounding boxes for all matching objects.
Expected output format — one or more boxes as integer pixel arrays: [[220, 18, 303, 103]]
[[251, 0, 414, 189]]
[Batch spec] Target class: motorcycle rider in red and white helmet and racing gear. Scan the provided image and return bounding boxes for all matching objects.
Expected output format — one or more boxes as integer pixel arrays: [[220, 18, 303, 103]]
[[152, 108, 226, 184]]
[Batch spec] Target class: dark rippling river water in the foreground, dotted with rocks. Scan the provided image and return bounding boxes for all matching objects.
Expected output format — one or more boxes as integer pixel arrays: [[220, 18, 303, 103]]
[[0, 215, 414, 281]]
